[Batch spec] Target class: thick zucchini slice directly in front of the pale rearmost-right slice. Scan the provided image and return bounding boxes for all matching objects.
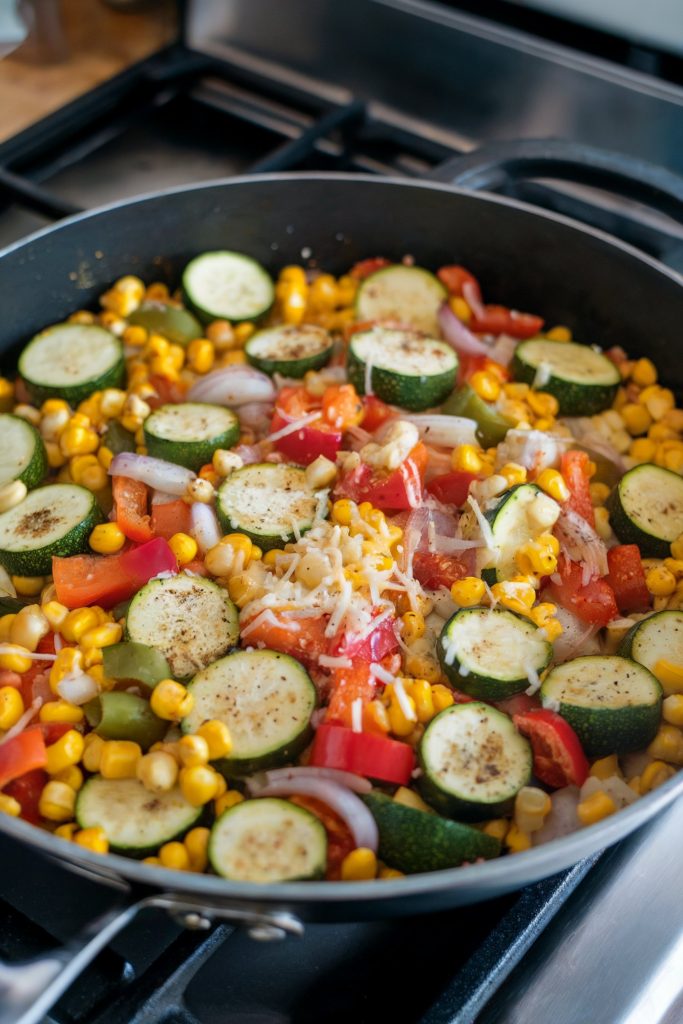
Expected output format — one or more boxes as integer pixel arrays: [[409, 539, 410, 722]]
[[347, 325, 458, 412]]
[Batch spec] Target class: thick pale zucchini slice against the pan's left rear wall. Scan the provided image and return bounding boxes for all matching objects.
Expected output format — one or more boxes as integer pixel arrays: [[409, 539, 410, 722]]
[[18, 324, 126, 406]]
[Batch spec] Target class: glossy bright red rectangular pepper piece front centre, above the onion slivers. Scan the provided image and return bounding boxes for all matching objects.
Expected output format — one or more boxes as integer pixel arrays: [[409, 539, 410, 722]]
[[310, 723, 415, 785]]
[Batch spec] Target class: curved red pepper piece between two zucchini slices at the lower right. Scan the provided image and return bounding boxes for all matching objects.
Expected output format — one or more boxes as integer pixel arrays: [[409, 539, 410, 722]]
[[512, 708, 590, 790]]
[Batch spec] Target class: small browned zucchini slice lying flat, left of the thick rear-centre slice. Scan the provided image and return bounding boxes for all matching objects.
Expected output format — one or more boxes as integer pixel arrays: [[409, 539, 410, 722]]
[[245, 324, 333, 377]]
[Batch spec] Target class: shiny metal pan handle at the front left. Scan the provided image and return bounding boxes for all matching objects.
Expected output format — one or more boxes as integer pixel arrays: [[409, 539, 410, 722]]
[[0, 893, 303, 1024]]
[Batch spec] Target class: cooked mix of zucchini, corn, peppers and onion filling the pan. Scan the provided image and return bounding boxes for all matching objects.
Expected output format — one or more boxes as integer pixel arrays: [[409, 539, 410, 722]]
[[0, 251, 683, 882]]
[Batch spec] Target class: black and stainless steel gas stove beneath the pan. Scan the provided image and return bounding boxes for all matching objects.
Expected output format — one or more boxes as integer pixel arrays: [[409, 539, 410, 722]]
[[0, 0, 683, 1024]]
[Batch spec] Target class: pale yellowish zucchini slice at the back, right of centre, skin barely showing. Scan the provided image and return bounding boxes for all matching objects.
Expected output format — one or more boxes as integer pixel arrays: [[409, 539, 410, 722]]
[[355, 264, 447, 337]]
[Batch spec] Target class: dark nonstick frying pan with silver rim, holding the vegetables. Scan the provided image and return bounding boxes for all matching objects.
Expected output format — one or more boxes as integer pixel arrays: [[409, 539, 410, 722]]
[[0, 155, 683, 1024]]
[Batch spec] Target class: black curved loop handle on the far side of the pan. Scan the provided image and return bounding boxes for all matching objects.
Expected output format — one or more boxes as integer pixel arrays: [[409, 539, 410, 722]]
[[429, 138, 683, 220]]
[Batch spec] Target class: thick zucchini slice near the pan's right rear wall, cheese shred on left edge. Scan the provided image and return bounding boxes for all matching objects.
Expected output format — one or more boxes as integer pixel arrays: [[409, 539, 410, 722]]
[[512, 338, 622, 416]]
